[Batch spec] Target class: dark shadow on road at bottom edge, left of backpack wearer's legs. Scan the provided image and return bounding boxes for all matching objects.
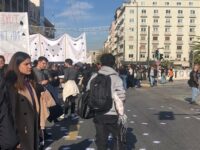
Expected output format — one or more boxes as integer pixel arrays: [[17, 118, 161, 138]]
[[59, 139, 92, 150]]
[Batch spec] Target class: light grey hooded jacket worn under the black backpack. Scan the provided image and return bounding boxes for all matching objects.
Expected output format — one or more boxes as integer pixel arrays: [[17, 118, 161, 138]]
[[87, 66, 126, 115]]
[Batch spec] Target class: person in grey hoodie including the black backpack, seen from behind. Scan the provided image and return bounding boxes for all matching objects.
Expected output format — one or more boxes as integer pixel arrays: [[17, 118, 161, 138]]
[[87, 54, 126, 150]]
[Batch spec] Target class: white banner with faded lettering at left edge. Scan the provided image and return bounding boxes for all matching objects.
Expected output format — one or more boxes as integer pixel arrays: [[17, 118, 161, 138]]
[[0, 12, 30, 63]]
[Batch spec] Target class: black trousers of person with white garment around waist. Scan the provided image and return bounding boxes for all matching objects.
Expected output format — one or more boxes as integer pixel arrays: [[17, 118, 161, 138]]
[[65, 96, 76, 114]]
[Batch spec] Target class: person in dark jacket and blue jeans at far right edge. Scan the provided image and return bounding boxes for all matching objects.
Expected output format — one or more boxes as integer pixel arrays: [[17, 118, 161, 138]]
[[189, 65, 199, 104]]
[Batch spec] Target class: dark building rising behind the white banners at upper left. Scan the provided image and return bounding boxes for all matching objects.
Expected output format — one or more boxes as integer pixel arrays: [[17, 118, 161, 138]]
[[0, 0, 55, 38]]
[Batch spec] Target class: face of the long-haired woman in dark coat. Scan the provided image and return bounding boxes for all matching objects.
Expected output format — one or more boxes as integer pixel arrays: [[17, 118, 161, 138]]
[[19, 58, 31, 75]]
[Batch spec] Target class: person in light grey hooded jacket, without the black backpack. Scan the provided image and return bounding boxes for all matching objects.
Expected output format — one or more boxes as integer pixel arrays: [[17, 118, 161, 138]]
[[87, 54, 125, 150]]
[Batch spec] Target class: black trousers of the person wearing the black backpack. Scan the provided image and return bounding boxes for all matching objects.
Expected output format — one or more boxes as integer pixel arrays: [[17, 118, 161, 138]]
[[94, 115, 125, 150]]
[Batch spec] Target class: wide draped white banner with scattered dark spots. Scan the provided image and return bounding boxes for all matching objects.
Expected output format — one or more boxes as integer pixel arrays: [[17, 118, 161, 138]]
[[30, 33, 87, 63]]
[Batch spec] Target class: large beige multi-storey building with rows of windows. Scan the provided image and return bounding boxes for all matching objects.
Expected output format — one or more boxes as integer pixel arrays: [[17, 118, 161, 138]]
[[107, 0, 200, 66]]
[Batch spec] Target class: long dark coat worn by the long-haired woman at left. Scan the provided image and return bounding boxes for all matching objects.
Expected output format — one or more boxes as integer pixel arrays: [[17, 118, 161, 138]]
[[0, 73, 39, 150]]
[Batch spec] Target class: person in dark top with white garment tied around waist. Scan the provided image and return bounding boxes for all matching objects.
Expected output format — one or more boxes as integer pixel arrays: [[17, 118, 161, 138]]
[[63, 59, 79, 119]]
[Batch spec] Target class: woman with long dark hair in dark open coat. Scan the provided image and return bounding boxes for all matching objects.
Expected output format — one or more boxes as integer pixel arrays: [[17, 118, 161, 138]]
[[6, 52, 39, 150]]
